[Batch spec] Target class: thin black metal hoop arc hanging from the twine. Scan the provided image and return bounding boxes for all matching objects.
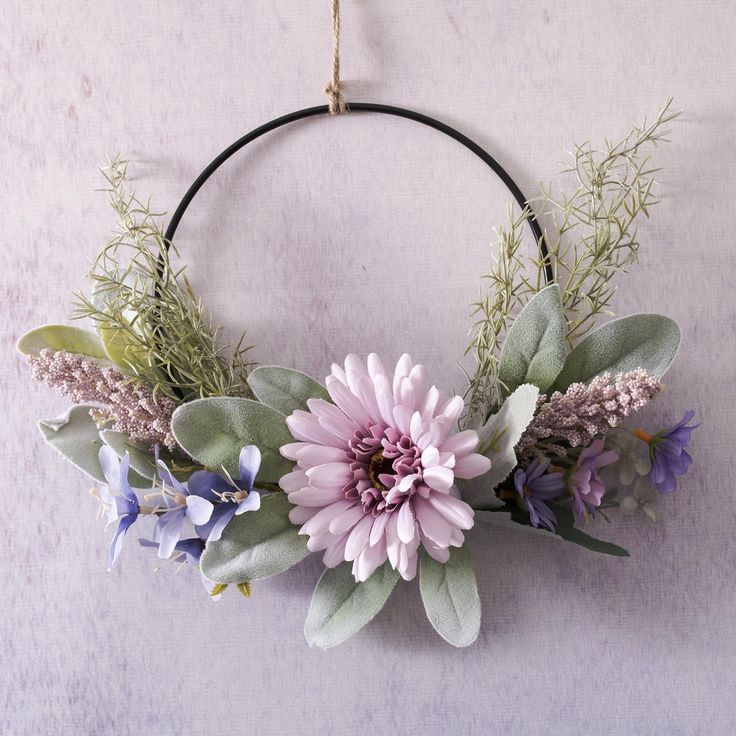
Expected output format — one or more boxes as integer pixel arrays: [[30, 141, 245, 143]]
[[161, 102, 554, 284]]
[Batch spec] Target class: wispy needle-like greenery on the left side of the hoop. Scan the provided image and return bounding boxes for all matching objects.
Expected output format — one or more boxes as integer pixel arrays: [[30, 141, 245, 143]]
[[74, 159, 251, 400]]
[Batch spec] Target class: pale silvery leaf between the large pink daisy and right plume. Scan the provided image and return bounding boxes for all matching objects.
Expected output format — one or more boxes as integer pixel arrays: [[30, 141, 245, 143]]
[[457, 384, 539, 509]]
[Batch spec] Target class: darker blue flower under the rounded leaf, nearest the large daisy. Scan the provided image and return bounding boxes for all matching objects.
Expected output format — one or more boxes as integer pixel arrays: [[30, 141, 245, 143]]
[[187, 445, 261, 542]]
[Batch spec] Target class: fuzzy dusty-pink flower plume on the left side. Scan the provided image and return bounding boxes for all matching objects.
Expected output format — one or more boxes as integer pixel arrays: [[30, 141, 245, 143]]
[[28, 348, 176, 450]]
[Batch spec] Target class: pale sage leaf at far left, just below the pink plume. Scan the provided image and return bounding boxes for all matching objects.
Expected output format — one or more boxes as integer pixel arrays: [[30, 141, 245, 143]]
[[38, 404, 151, 488]]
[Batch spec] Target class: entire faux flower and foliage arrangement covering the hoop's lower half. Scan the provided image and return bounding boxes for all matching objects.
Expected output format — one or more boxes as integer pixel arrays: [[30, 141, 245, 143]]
[[18, 103, 697, 648]]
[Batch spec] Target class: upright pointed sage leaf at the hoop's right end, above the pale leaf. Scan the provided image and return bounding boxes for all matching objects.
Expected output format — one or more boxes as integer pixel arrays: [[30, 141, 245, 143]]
[[498, 284, 567, 396]]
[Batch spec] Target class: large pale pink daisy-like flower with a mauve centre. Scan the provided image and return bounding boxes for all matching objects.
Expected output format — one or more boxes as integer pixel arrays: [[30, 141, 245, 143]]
[[280, 354, 491, 581]]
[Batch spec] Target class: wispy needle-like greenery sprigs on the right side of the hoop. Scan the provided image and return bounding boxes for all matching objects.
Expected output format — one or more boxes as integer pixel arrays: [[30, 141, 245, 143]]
[[466, 99, 679, 421]]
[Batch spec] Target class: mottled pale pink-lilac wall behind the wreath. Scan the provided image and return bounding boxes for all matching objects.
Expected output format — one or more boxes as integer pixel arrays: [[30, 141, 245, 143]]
[[0, 0, 736, 736]]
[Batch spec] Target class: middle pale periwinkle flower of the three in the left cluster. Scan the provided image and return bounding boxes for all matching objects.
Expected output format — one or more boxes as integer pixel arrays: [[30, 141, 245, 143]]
[[153, 460, 215, 559]]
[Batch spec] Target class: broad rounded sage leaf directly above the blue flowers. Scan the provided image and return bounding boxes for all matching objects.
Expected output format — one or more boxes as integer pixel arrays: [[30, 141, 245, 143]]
[[171, 396, 294, 483]]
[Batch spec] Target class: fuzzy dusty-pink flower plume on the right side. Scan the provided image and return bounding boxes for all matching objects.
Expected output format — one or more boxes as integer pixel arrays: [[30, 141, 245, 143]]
[[517, 368, 660, 459]]
